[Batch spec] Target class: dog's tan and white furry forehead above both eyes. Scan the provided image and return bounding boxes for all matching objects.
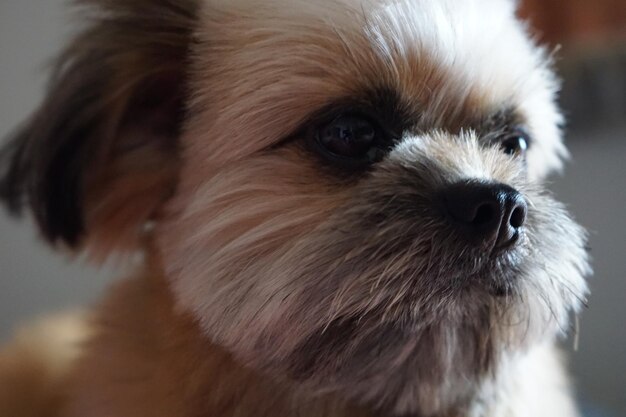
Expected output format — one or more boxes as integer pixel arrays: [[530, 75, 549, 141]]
[[185, 0, 563, 176]]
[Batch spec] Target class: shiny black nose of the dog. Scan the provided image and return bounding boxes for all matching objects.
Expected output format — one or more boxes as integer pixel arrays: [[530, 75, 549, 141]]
[[443, 181, 528, 249]]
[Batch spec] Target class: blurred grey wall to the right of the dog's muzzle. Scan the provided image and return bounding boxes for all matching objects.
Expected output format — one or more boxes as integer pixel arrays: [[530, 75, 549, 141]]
[[552, 125, 626, 417]]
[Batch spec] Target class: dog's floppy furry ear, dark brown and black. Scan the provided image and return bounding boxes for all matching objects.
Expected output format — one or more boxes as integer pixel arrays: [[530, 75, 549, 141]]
[[0, 0, 197, 255]]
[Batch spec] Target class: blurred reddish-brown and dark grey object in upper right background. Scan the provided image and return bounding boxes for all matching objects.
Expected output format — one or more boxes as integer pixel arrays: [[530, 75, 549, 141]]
[[520, 0, 626, 130]]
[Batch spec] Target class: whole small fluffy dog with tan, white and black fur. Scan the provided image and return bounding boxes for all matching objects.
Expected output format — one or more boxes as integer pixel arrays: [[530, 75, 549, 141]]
[[0, 0, 590, 417]]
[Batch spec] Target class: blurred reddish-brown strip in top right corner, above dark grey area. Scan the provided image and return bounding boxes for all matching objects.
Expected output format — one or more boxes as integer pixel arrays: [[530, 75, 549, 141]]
[[520, 0, 626, 45]]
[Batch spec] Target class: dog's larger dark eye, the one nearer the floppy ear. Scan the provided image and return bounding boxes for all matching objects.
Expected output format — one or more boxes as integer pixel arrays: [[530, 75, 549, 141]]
[[315, 115, 383, 162]]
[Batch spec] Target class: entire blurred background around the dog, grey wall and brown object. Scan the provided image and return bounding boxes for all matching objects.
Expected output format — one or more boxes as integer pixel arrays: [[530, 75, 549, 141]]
[[0, 0, 626, 417]]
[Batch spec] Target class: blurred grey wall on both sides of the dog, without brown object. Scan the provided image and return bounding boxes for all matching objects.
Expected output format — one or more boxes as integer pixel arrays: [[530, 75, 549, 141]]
[[0, 0, 626, 416]]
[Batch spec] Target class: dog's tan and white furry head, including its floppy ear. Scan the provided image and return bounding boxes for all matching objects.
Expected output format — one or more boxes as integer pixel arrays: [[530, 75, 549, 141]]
[[4, 0, 588, 415]]
